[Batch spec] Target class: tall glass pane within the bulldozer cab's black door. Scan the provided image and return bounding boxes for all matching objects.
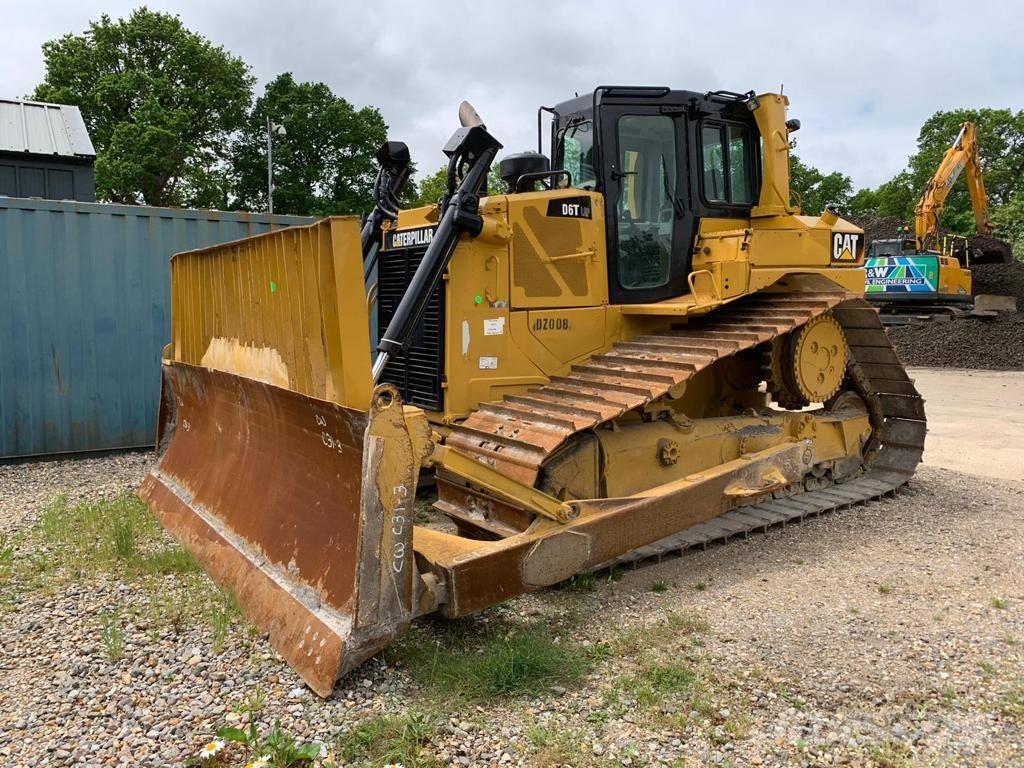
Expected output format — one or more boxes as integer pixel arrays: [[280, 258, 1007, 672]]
[[615, 115, 676, 289]]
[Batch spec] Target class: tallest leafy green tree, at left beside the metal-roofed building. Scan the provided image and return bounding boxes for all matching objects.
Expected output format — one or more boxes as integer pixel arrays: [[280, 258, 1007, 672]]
[[35, 6, 254, 207]]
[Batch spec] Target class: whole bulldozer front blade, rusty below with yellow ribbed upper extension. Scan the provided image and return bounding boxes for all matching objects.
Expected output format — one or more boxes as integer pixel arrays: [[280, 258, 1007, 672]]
[[139, 218, 424, 695]]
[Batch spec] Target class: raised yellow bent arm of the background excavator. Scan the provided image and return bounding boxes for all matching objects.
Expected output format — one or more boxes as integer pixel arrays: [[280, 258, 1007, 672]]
[[914, 122, 992, 251]]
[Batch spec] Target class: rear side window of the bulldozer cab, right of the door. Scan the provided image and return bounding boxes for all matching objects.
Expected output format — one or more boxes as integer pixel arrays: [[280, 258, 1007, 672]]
[[700, 122, 754, 206]]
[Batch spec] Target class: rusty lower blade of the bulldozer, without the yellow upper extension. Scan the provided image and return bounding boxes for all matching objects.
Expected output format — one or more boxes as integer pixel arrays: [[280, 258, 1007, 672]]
[[139, 362, 419, 696]]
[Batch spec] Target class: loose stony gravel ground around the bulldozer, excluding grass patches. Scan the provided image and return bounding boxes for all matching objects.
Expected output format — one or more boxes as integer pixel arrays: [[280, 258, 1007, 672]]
[[0, 455, 1024, 767]]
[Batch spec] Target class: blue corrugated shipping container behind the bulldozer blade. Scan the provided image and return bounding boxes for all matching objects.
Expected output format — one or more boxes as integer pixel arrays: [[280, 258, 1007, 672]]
[[0, 197, 313, 458]]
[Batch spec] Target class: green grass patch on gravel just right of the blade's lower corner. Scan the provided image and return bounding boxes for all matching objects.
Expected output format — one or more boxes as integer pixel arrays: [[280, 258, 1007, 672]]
[[387, 620, 597, 698]]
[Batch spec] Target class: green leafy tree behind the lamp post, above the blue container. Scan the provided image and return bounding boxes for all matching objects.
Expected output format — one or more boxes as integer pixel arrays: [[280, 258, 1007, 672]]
[[231, 73, 387, 216]]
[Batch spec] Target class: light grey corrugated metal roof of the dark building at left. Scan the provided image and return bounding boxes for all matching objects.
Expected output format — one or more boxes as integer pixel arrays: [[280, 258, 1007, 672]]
[[0, 98, 96, 158]]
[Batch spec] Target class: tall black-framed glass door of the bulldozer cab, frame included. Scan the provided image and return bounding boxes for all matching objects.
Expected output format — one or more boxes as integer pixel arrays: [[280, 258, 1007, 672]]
[[600, 105, 696, 304]]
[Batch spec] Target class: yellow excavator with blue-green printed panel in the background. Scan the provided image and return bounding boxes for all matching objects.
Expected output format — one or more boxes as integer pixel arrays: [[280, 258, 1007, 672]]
[[865, 122, 992, 312]]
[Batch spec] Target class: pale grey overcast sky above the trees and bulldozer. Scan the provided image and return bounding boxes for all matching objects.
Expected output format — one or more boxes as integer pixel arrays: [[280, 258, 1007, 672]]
[[0, 0, 1024, 186]]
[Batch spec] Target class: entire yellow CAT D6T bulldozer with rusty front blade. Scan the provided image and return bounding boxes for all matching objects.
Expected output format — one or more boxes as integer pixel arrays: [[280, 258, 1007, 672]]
[[139, 86, 926, 695]]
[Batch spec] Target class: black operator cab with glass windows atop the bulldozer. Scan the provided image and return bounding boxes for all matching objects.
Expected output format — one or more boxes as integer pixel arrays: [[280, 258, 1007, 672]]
[[539, 86, 761, 304]]
